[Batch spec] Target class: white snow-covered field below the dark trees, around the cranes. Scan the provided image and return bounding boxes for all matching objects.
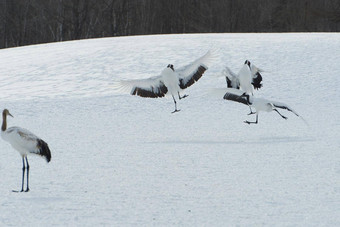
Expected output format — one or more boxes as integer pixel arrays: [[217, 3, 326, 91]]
[[0, 33, 340, 226]]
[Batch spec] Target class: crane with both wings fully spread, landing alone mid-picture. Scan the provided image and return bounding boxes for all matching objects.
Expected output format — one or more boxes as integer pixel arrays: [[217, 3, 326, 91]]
[[114, 50, 217, 113]]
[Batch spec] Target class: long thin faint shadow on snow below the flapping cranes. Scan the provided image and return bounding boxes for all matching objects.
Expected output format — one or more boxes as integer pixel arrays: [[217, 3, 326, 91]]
[[143, 136, 315, 144]]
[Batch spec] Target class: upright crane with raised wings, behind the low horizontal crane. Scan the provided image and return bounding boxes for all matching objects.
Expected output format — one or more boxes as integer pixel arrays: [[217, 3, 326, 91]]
[[223, 60, 263, 115]]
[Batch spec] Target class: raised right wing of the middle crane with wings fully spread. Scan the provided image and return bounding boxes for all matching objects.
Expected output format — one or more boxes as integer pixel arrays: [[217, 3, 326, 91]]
[[176, 50, 218, 89]]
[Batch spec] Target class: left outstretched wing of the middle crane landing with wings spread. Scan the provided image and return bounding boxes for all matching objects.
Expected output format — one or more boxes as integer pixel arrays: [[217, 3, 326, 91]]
[[113, 76, 168, 98]]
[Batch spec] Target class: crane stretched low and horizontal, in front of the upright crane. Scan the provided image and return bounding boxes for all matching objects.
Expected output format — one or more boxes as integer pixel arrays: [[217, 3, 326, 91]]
[[219, 88, 300, 124]]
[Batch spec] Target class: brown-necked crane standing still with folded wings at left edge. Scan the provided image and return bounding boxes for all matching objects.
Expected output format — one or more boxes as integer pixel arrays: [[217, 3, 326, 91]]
[[1, 109, 51, 192]]
